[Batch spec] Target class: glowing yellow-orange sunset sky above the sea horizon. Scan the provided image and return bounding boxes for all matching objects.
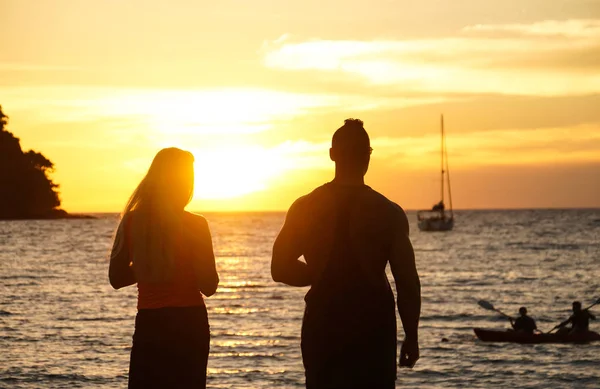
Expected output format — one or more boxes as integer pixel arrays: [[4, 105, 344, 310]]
[[0, 0, 600, 212]]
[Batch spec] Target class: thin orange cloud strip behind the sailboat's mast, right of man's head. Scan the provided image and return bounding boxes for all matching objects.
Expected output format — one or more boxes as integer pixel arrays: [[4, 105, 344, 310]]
[[372, 124, 600, 168]]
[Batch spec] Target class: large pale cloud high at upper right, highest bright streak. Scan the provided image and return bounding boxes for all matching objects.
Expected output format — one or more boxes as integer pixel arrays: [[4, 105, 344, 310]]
[[263, 20, 600, 96]]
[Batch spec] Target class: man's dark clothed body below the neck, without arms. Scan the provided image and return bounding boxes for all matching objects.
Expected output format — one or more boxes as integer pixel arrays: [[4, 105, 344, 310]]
[[287, 183, 404, 388]]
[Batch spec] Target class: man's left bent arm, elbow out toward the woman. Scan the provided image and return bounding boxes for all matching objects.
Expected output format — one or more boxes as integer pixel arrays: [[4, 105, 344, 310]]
[[271, 201, 311, 286]]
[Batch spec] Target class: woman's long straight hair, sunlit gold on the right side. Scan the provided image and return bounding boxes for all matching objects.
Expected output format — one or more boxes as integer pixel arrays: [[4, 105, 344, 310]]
[[122, 147, 194, 282]]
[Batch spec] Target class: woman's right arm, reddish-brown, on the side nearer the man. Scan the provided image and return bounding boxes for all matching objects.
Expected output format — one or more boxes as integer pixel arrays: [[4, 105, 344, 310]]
[[188, 213, 219, 296]]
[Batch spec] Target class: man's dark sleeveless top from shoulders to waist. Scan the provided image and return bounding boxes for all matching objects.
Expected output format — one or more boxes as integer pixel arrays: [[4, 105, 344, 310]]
[[296, 183, 403, 306]]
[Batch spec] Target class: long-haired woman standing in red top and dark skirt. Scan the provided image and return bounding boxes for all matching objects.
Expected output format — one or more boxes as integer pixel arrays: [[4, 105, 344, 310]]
[[109, 148, 219, 388]]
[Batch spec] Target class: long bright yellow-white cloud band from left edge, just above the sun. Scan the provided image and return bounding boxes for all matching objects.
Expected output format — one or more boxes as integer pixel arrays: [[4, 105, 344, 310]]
[[0, 86, 445, 144]]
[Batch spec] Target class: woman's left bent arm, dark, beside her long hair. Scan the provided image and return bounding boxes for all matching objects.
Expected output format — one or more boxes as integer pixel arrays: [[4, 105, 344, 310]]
[[108, 219, 136, 289]]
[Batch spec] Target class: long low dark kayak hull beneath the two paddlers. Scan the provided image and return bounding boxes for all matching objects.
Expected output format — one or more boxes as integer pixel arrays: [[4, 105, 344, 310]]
[[473, 328, 600, 344]]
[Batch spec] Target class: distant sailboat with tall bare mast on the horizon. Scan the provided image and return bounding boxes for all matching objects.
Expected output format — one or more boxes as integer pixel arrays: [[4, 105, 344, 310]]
[[417, 115, 454, 231]]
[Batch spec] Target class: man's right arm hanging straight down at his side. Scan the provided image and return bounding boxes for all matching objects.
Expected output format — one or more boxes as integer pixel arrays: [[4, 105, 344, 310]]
[[390, 211, 421, 367]]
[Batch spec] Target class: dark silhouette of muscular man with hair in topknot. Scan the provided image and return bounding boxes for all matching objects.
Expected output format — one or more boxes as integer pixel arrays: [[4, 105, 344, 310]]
[[271, 119, 421, 389]]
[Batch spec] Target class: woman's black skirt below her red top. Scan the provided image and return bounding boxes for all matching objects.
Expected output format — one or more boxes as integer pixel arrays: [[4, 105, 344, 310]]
[[129, 306, 210, 389]]
